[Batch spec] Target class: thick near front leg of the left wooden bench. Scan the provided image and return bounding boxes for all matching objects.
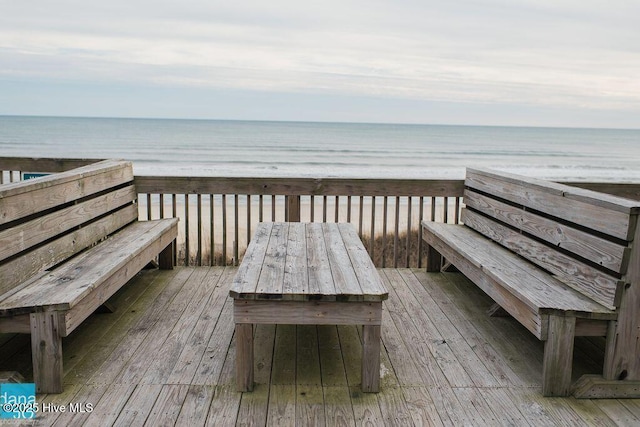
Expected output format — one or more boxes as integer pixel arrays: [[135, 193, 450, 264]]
[[31, 312, 62, 393]]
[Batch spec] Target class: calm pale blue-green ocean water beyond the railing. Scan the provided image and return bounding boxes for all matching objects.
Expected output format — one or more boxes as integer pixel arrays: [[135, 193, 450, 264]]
[[0, 116, 640, 182]]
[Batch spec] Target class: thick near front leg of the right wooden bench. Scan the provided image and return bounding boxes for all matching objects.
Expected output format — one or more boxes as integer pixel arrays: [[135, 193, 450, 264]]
[[542, 316, 576, 396]]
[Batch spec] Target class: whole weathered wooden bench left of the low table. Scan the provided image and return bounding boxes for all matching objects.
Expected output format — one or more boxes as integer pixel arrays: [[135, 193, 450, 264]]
[[0, 160, 177, 393]]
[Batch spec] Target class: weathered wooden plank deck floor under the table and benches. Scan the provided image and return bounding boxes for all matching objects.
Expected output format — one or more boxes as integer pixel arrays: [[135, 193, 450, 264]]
[[0, 267, 640, 426]]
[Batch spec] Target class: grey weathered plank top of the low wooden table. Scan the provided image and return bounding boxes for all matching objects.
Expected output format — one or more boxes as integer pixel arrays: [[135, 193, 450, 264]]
[[229, 223, 388, 302]]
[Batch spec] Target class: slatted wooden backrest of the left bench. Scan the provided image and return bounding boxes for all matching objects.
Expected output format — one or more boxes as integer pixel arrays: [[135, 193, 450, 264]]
[[0, 161, 138, 295]]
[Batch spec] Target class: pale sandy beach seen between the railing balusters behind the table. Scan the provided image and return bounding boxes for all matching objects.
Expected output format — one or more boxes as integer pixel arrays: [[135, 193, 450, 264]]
[[139, 195, 455, 264]]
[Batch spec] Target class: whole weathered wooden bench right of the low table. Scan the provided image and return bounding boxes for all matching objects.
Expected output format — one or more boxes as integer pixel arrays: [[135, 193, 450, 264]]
[[422, 169, 640, 397]]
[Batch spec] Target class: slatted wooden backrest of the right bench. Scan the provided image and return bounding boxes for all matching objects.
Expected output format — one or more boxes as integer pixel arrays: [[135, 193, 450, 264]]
[[462, 169, 640, 308]]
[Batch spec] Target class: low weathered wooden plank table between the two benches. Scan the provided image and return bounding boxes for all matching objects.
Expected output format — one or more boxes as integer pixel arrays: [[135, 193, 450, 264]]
[[229, 223, 388, 392]]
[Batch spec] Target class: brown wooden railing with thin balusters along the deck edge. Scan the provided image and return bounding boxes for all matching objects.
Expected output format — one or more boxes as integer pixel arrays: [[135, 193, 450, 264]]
[[0, 158, 640, 267]]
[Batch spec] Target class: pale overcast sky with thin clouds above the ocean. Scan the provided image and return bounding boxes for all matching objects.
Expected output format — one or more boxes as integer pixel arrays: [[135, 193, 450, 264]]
[[0, 0, 640, 128]]
